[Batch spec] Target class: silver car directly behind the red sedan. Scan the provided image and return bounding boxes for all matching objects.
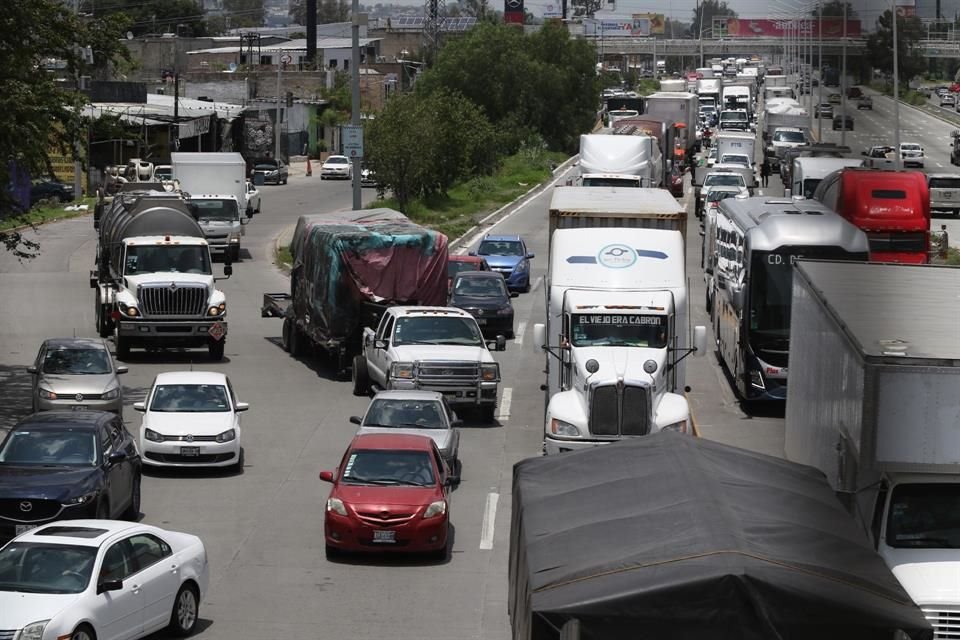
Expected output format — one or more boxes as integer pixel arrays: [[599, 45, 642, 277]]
[[350, 390, 460, 477]]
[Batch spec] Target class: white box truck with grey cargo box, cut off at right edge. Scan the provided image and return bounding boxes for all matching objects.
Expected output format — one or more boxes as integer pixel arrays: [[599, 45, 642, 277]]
[[785, 260, 960, 638]]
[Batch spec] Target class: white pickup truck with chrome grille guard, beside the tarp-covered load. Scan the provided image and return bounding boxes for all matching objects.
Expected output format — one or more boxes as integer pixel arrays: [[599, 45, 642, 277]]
[[353, 307, 507, 422]]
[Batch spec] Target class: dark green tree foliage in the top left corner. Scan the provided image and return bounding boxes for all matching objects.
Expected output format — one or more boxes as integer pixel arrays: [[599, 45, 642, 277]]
[[0, 0, 129, 258]]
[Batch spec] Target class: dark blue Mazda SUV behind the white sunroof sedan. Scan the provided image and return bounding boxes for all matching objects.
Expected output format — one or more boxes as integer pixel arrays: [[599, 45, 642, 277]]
[[0, 411, 141, 540]]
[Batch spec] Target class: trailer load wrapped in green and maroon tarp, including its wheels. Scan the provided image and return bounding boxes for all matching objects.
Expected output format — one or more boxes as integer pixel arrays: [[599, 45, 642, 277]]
[[261, 208, 447, 374]]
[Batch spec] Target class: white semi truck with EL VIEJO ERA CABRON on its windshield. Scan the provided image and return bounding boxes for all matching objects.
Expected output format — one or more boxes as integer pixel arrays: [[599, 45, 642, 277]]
[[533, 187, 706, 454]]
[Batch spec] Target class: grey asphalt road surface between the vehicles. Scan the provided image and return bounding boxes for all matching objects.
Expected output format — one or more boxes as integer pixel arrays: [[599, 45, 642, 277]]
[[0, 162, 783, 640]]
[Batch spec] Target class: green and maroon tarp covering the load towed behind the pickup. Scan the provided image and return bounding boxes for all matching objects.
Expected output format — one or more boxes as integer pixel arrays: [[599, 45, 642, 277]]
[[290, 209, 447, 338]]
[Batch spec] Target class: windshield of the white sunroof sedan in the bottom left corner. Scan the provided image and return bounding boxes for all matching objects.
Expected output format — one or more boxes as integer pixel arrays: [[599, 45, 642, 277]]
[[0, 541, 97, 594]]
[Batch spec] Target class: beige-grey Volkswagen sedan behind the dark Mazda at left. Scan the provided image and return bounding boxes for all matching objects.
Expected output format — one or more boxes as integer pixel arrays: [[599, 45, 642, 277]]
[[27, 338, 128, 414]]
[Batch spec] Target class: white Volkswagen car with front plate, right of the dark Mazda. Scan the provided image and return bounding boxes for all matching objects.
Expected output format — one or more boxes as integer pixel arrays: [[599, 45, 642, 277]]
[[133, 371, 249, 469]]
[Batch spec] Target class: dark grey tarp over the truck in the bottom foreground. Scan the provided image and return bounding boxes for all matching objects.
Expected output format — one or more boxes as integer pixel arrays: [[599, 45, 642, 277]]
[[508, 432, 932, 640]]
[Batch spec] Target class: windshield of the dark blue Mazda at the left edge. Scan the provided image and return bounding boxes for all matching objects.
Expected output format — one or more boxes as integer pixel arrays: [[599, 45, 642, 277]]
[[0, 428, 97, 467]]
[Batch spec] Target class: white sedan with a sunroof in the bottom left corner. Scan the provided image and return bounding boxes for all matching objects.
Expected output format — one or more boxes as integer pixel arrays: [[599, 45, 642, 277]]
[[0, 520, 209, 640]]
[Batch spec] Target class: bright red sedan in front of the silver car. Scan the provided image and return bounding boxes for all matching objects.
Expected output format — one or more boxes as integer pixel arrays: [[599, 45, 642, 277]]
[[320, 433, 456, 558]]
